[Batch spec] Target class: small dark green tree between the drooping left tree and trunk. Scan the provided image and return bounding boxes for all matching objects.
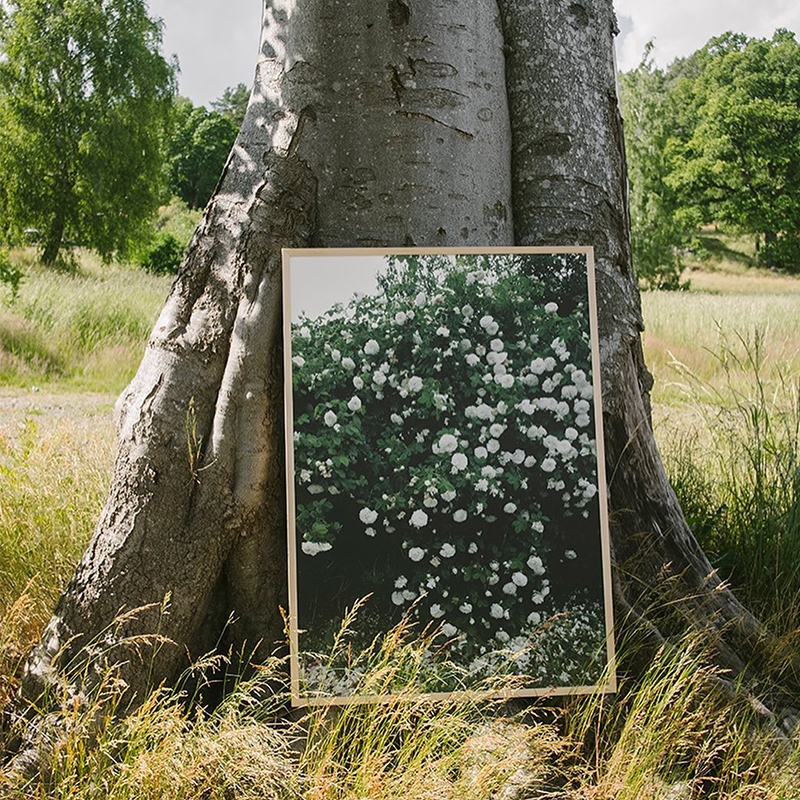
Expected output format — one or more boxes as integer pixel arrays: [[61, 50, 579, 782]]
[[168, 98, 239, 208]]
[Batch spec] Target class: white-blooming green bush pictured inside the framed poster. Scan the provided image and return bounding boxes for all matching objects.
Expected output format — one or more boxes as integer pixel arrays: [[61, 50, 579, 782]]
[[292, 253, 599, 672]]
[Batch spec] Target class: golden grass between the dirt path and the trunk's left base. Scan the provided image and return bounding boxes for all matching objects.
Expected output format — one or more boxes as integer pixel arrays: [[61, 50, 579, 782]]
[[0, 406, 113, 706]]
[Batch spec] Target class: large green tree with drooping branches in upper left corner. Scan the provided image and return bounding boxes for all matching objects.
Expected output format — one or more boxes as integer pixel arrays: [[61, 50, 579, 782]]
[[0, 0, 175, 264]]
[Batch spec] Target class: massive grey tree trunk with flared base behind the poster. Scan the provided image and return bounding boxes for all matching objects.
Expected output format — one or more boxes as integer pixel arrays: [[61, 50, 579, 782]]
[[14, 0, 800, 728]]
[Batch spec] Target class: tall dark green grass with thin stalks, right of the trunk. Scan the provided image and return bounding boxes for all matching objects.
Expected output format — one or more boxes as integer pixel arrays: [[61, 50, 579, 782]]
[[664, 332, 800, 635]]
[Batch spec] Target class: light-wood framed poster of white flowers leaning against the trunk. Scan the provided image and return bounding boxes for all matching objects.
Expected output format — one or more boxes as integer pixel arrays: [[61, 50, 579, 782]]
[[283, 248, 615, 705]]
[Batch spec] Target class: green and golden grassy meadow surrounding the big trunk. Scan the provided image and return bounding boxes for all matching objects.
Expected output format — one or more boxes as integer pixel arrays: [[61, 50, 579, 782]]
[[0, 251, 800, 800]]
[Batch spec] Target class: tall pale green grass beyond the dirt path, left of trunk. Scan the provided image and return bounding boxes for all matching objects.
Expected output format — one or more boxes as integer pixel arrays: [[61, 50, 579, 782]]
[[0, 250, 170, 392]]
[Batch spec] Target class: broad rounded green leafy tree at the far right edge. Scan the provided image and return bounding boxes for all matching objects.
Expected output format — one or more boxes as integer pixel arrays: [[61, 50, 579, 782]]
[[668, 30, 800, 268]]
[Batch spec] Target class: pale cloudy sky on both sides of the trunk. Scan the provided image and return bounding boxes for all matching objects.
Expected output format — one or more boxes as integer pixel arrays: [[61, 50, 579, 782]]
[[149, 0, 800, 105]]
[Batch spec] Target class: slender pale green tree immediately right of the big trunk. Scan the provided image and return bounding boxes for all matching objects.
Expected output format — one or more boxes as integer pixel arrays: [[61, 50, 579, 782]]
[[620, 43, 686, 289]]
